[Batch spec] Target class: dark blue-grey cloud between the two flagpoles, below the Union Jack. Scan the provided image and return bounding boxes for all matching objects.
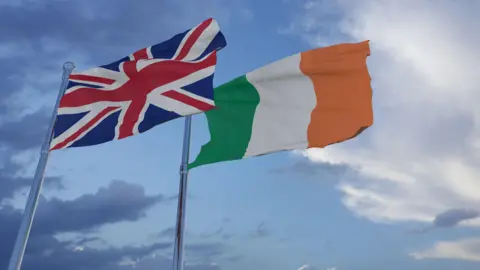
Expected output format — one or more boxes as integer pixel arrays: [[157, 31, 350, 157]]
[[33, 181, 163, 234]]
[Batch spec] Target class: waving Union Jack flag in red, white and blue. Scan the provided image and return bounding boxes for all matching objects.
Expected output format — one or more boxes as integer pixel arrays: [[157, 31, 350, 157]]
[[50, 18, 226, 150]]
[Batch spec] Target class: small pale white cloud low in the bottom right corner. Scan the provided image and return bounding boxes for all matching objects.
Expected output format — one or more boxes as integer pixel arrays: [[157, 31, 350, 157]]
[[410, 238, 480, 261]]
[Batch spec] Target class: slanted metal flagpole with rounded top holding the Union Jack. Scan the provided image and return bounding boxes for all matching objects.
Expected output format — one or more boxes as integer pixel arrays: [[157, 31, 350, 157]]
[[8, 62, 75, 270]]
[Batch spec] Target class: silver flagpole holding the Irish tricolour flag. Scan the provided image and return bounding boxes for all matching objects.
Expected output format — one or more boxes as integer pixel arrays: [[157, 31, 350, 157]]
[[173, 115, 192, 270]]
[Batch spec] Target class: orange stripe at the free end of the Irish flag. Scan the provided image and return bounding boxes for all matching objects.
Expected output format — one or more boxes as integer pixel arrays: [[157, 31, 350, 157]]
[[300, 41, 373, 148]]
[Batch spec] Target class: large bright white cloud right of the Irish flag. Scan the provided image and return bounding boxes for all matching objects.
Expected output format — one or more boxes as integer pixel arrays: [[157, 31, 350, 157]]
[[290, 0, 480, 226]]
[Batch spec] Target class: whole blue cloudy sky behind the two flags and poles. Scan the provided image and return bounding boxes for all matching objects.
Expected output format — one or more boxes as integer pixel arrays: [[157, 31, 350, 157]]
[[0, 0, 480, 270]]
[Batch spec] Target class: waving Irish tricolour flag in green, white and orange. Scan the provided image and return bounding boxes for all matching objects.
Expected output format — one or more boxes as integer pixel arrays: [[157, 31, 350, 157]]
[[189, 41, 373, 168]]
